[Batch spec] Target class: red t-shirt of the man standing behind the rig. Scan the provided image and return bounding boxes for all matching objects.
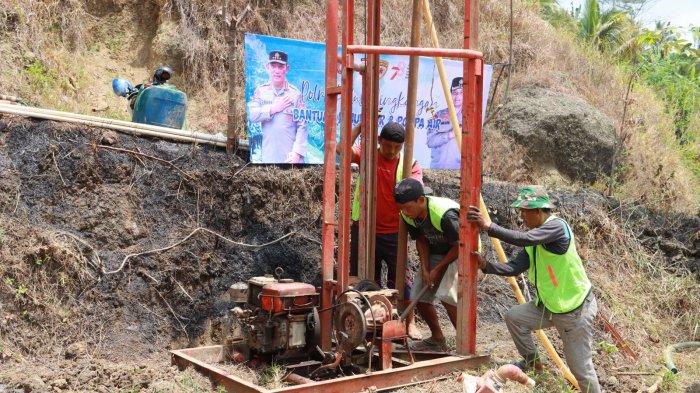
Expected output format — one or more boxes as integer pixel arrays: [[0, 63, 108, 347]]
[[352, 146, 423, 235]]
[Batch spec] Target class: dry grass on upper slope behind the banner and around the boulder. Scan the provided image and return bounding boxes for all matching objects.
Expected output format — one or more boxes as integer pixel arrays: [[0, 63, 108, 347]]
[[0, 0, 700, 212]]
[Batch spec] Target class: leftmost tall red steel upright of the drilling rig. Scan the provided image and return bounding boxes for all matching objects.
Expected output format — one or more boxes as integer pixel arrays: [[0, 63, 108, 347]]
[[320, 0, 338, 350]]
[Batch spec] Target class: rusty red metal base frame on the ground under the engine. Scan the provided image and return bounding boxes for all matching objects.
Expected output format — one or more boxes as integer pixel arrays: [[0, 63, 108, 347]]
[[170, 345, 490, 393]]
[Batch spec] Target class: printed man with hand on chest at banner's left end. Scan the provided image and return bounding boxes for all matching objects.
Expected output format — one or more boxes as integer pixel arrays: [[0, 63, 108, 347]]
[[248, 50, 308, 164]]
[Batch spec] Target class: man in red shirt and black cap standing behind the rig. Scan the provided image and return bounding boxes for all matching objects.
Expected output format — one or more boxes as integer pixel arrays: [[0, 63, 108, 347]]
[[336, 122, 423, 339]]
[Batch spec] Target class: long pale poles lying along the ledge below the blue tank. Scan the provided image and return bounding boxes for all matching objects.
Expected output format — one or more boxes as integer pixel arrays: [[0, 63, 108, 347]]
[[0, 104, 226, 146]]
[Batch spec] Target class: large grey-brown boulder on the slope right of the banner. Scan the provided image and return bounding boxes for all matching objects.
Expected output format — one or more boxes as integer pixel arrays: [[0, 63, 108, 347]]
[[494, 87, 615, 183]]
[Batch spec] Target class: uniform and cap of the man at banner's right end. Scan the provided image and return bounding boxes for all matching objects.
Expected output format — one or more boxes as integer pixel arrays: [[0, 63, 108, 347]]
[[427, 77, 462, 169]]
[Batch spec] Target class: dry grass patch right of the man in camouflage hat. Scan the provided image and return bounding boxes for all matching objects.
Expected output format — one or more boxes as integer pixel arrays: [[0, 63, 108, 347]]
[[577, 207, 700, 362]]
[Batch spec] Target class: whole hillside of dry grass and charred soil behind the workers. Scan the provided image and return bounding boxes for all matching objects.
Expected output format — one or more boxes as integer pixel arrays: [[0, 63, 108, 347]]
[[0, 0, 700, 392]]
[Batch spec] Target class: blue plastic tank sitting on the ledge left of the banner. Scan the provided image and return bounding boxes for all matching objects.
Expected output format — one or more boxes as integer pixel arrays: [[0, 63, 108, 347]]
[[131, 84, 187, 128]]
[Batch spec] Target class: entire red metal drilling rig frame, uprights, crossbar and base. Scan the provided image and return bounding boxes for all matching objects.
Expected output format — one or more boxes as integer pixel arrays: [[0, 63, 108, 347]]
[[171, 0, 488, 393]]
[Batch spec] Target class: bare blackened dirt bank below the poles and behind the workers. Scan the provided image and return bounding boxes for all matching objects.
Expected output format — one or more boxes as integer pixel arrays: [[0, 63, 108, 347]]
[[0, 116, 700, 392]]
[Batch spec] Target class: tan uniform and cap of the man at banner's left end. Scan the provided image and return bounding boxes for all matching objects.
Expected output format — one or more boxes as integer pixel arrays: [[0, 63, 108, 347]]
[[248, 51, 308, 163]]
